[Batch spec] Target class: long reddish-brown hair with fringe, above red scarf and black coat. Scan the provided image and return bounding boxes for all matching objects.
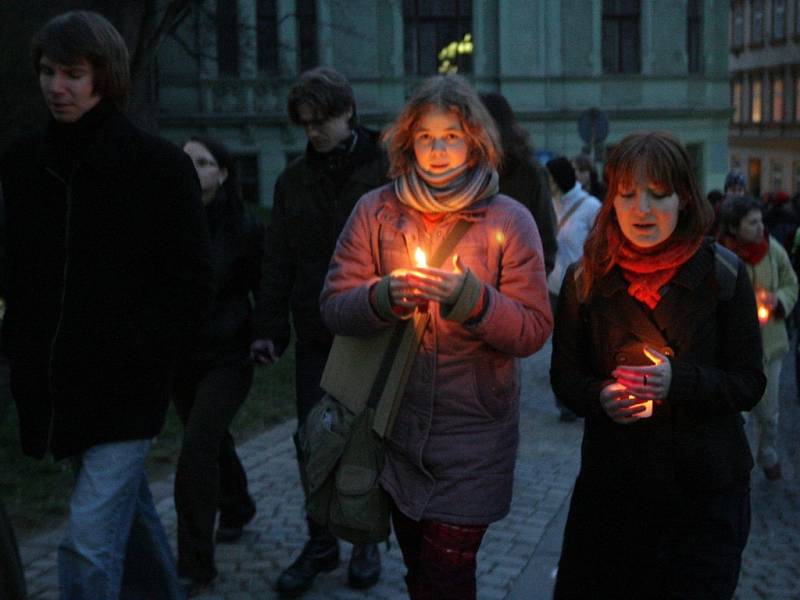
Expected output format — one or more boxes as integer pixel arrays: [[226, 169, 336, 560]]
[[579, 131, 714, 301]]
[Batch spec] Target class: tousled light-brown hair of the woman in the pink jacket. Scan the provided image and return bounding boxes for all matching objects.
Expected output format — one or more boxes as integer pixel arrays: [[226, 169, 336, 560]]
[[383, 74, 502, 178]]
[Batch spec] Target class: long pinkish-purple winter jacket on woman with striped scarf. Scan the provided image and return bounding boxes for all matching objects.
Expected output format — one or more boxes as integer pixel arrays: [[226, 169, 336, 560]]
[[320, 185, 553, 524]]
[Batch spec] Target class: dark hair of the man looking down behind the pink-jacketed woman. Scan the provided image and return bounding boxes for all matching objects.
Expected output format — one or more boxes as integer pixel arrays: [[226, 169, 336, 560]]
[[287, 67, 358, 127]]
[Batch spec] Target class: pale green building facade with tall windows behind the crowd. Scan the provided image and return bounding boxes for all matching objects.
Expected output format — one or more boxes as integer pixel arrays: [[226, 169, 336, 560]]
[[158, 0, 731, 205]]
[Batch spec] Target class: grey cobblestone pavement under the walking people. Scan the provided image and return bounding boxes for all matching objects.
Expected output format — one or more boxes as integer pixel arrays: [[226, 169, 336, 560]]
[[15, 346, 800, 600]]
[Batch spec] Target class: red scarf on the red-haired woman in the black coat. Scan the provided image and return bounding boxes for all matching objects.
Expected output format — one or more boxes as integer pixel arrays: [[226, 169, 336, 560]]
[[615, 231, 703, 310]]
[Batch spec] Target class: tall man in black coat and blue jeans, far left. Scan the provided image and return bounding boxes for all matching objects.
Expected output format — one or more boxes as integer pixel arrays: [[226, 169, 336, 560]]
[[0, 11, 213, 600]]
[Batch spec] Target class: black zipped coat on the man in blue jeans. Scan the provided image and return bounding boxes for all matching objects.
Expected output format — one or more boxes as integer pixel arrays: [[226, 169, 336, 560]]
[[0, 101, 213, 458]]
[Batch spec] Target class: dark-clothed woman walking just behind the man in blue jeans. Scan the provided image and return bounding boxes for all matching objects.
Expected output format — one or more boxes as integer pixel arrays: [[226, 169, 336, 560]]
[[173, 137, 264, 589]]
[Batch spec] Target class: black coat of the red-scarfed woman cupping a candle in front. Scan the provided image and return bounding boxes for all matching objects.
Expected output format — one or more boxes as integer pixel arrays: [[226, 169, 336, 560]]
[[550, 240, 766, 597]]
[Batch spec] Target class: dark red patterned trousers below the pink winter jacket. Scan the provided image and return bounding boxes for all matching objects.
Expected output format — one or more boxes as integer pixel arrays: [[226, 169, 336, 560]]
[[392, 507, 487, 600]]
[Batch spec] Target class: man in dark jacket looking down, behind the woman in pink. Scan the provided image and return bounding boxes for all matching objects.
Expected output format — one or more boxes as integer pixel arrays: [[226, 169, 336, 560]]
[[252, 68, 387, 595]]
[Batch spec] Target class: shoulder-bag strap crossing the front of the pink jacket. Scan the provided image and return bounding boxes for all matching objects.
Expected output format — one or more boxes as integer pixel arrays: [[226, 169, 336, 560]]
[[367, 219, 472, 437]]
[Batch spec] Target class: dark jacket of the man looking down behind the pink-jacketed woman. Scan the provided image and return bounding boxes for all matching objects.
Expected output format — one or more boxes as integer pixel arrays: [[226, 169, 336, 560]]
[[254, 127, 388, 350]]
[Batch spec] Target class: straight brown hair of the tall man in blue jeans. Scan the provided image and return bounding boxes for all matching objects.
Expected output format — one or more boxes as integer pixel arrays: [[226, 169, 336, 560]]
[[31, 10, 131, 109]]
